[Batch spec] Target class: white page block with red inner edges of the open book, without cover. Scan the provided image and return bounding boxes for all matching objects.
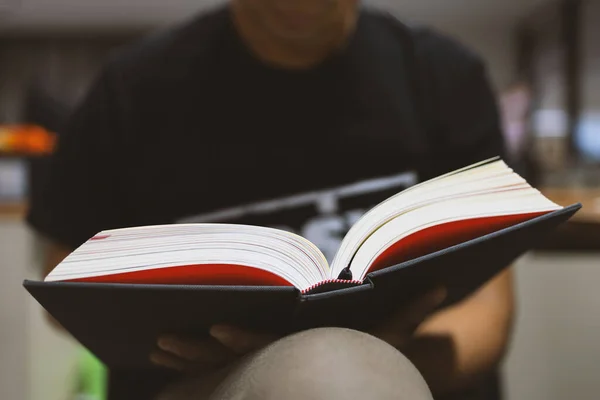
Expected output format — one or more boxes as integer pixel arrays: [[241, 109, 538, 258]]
[[46, 160, 562, 292]]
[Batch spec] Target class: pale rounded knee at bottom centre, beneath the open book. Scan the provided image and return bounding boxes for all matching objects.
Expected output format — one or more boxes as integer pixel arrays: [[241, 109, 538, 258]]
[[211, 328, 432, 400]]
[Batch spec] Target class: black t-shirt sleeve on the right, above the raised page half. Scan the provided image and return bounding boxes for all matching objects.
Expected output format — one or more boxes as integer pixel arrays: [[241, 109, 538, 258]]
[[418, 28, 506, 175]]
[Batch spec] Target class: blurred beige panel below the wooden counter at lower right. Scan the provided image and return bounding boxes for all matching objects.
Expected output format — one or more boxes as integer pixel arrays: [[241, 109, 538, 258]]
[[504, 253, 600, 400]]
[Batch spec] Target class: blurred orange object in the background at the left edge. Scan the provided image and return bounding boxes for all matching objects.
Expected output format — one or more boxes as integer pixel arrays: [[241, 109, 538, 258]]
[[0, 125, 56, 155]]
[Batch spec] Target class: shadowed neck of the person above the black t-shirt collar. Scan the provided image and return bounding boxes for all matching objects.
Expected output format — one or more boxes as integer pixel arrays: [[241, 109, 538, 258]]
[[231, 1, 358, 69]]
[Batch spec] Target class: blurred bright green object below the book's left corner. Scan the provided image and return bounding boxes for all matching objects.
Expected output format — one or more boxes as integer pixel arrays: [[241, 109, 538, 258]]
[[75, 348, 107, 400]]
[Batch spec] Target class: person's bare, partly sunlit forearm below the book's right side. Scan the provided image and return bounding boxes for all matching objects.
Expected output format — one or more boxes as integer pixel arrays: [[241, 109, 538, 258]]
[[404, 269, 514, 395]]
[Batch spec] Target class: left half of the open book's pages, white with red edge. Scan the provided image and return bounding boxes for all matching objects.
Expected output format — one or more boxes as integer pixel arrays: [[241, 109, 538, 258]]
[[46, 224, 330, 290]]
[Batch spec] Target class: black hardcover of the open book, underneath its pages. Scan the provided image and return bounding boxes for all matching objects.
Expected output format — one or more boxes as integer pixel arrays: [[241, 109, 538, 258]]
[[24, 204, 581, 369]]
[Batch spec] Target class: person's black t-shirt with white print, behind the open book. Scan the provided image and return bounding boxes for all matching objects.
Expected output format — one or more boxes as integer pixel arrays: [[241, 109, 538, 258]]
[[28, 3, 504, 399]]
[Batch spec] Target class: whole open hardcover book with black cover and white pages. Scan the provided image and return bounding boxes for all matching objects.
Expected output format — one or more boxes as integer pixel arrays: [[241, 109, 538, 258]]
[[24, 159, 581, 369]]
